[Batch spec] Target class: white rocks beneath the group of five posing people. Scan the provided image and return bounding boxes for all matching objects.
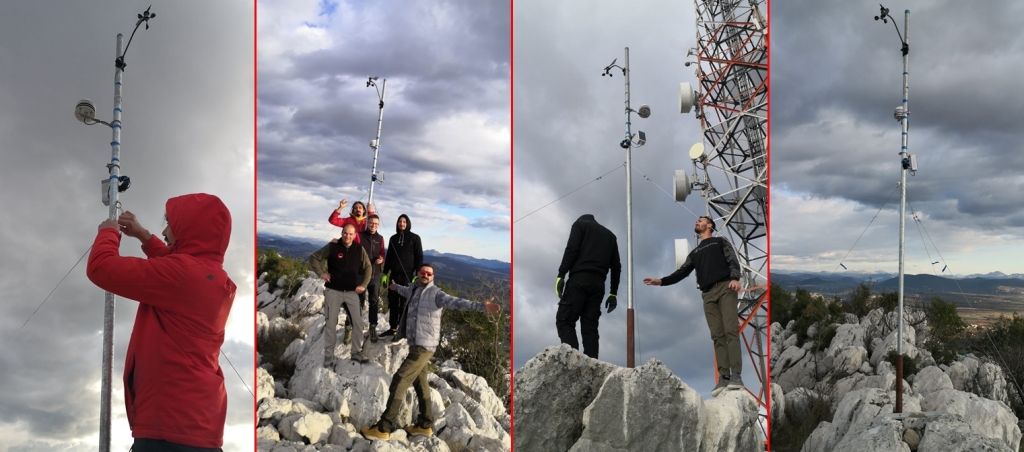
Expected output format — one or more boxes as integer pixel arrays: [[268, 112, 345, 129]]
[[256, 270, 512, 452]]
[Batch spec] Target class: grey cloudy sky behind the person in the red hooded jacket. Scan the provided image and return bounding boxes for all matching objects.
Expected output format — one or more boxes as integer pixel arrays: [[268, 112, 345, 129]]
[[0, 0, 254, 451]]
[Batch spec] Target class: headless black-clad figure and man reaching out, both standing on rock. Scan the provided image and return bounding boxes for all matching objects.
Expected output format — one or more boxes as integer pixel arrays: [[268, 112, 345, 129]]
[[555, 214, 743, 397]]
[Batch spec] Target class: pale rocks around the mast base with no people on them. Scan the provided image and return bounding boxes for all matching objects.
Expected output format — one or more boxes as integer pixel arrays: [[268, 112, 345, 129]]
[[771, 309, 1021, 452]]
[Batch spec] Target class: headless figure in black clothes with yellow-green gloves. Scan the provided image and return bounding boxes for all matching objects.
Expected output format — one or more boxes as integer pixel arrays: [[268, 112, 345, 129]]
[[555, 214, 623, 359]]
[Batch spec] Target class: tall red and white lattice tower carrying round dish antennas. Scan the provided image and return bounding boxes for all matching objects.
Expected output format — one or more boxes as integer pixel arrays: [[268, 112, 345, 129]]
[[674, 0, 769, 438]]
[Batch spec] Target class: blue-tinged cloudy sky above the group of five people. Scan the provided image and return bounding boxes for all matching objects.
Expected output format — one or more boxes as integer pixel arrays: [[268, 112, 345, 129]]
[[257, 0, 511, 261]]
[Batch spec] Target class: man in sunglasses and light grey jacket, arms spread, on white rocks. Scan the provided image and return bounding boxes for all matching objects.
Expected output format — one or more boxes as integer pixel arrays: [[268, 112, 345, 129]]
[[360, 263, 502, 441]]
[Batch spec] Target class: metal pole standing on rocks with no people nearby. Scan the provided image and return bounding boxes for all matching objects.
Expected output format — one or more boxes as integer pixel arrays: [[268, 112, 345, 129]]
[[894, 9, 910, 413]]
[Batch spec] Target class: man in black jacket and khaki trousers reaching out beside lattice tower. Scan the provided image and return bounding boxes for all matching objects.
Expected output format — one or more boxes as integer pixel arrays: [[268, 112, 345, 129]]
[[643, 216, 743, 397]]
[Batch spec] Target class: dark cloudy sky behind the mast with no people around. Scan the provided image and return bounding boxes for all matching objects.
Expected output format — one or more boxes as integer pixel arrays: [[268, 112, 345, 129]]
[[770, 1, 1024, 276]]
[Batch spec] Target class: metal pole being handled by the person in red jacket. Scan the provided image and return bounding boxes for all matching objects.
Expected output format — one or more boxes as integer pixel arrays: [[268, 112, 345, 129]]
[[99, 33, 124, 452]]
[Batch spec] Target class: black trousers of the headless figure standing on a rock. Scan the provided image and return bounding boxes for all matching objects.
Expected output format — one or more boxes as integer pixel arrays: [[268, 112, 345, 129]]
[[555, 274, 604, 359]]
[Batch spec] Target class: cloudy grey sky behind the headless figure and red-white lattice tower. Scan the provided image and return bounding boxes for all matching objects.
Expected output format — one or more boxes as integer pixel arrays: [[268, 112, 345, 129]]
[[513, 1, 767, 398]]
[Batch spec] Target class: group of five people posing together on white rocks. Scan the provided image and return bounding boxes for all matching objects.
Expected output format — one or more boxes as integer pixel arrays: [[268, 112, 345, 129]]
[[310, 200, 501, 440]]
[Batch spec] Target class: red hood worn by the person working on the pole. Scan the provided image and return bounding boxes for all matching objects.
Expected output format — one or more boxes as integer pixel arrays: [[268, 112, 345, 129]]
[[165, 193, 231, 264]]
